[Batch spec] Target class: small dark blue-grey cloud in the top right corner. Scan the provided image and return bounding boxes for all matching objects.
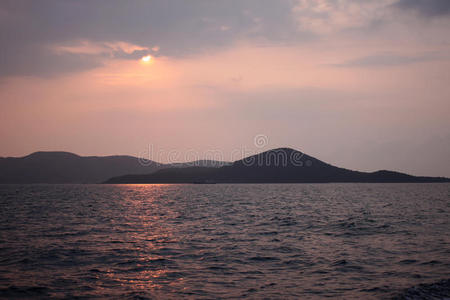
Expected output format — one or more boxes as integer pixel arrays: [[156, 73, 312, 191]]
[[394, 0, 450, 17]]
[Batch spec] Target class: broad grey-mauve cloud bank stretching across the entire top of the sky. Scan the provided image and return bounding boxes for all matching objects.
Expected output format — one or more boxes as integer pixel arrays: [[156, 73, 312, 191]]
[[0, 0, 450, 77]]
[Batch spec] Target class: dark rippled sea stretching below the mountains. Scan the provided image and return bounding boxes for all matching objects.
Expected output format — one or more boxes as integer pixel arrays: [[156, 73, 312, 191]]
[[0, 184, 450, 299]]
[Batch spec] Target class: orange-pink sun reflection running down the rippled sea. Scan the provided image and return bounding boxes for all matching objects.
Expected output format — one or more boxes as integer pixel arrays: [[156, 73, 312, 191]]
[[100, 184, 183, 291]]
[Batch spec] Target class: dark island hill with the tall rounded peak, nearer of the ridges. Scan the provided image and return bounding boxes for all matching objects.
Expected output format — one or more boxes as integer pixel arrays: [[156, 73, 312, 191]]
[[106, 148, 450, 183]]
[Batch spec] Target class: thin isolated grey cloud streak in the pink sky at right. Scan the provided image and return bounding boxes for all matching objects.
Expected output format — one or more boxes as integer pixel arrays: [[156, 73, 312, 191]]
[[333, 53, 438, 67]]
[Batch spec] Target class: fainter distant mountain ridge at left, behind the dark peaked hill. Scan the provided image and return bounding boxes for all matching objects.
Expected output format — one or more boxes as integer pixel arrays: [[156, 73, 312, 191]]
[[0, 152, 229, 183]]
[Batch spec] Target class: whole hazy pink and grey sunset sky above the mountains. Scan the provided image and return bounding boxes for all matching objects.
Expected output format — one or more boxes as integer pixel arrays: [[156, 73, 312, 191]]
[[0, 0, 450, 177]]
